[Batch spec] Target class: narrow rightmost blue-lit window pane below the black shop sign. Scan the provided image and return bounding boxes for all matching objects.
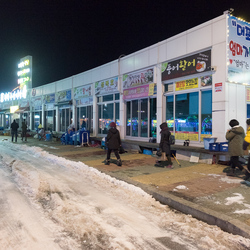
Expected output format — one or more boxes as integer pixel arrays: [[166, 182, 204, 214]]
[[201, 90, 212, 141]]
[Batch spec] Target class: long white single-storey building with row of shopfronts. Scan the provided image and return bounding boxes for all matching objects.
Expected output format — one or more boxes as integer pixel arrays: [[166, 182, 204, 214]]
[[0, 13, 250, 146]]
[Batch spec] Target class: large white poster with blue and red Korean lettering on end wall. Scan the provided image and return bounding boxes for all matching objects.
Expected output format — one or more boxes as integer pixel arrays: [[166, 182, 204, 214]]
[[227, 16, 250, 83]]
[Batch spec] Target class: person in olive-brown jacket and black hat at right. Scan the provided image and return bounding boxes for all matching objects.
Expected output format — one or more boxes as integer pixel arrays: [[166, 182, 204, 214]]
[[226, 119, 245, 176]]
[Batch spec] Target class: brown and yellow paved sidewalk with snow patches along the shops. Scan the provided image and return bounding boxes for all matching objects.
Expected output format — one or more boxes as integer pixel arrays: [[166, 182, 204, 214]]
[[3, 136, 250, 238]]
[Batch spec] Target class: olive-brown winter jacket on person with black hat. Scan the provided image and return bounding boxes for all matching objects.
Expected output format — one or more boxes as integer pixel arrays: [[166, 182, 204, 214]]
[[226, 125, 245, 156]]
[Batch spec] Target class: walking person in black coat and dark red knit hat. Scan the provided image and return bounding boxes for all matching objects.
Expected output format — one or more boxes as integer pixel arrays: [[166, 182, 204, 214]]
[[105, 122, 122, 166]]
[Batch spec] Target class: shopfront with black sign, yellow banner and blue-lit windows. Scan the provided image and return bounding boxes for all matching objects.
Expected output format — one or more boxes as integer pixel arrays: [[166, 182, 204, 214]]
[[162, 50, 212, 142]]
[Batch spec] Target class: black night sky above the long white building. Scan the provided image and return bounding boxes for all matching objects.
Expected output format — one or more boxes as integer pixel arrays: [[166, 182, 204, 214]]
[[0, 0, 250, 92]]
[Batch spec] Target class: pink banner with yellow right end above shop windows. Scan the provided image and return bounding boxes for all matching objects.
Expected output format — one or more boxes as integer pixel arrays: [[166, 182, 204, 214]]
[[123, 83, 156, 100]]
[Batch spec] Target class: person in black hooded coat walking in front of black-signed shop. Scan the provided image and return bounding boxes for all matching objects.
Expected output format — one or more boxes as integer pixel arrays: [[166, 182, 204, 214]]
[[156, 122, 173, 168]]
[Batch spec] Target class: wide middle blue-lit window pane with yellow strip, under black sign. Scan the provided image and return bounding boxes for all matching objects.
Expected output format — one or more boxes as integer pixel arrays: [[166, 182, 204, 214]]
[[175, 92, 199, 141]]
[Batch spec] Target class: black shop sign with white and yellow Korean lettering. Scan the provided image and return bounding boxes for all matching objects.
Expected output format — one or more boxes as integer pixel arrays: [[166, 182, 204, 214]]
[[161, 50, 211, 81]]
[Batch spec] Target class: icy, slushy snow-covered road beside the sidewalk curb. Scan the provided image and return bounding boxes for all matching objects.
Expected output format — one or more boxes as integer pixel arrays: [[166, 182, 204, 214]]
[[0, 141, 250, 250]]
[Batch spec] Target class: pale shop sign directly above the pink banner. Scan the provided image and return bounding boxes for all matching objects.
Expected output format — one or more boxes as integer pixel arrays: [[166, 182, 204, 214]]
[[122, 68, 154, 89]]
